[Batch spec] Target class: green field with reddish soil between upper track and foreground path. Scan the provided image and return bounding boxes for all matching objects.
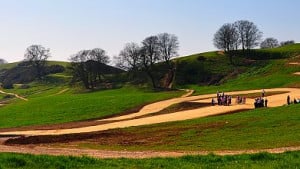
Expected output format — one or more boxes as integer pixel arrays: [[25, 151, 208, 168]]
[[68, 105, 300, 151]]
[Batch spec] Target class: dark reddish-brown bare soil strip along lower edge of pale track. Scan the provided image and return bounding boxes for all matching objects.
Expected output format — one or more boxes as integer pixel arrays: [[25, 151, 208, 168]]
[[4, 111, 251, 146]]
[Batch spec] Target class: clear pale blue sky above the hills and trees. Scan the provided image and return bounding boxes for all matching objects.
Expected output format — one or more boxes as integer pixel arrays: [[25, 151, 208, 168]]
[[0, 0, 300, 62]]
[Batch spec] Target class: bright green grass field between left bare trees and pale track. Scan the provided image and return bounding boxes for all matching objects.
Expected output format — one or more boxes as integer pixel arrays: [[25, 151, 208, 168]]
[[0, 87, 183, 128]]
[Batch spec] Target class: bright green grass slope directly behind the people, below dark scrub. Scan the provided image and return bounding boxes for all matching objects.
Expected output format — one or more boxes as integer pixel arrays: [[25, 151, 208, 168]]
[[189, 60, 300, 94]]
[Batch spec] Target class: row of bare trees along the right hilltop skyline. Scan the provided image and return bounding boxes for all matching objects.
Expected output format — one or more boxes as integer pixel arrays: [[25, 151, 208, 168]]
[[213, 20, 295, 64]]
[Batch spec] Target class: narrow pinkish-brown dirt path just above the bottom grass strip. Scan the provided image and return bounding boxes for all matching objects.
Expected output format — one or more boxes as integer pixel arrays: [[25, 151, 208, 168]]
[[0, 145, 300, 159]]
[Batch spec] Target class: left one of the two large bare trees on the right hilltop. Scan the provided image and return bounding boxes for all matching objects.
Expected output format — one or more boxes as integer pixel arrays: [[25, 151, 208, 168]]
[[213, 23, 239, 63]]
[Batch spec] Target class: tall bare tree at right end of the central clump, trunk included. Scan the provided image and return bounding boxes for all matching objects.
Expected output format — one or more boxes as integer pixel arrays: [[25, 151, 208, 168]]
[[157, 33, 179, 88]]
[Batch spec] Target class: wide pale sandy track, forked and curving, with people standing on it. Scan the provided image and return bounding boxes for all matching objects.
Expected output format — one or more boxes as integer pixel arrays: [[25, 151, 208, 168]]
[[0, 88, 300, 136]]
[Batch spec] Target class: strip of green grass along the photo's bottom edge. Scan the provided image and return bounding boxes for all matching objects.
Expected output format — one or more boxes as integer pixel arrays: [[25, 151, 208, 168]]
[[0, 151, 300, 169]]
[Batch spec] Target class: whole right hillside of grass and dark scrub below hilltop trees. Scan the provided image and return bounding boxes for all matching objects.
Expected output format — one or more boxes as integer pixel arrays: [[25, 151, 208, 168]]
[[176, 44, 300, 93]]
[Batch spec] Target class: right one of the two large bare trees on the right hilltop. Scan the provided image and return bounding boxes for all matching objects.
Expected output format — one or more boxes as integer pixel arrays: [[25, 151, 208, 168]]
[[234, 20, 262, 51]]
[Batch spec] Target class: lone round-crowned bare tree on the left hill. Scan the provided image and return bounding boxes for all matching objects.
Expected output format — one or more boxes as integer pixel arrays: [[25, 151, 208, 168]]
[[24, 45, 51, 79]]
